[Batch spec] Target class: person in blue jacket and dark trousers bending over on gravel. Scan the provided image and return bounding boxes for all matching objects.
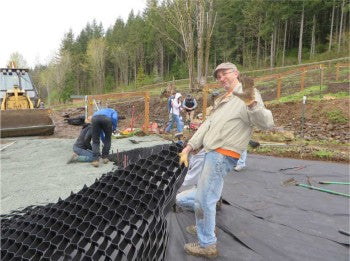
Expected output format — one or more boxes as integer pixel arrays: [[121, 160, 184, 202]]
[[91, 108, 118, 167]]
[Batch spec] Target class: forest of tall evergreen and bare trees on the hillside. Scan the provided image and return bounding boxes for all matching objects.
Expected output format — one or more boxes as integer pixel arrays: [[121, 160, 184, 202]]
[[21, 0, 350, 101]]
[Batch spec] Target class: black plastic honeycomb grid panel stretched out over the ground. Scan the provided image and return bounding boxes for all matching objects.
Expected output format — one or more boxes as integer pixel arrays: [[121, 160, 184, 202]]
[[1, 145, 186, 261]]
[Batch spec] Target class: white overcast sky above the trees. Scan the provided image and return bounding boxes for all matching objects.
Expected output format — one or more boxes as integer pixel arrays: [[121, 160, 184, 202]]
[[0, 0, 146, 67]]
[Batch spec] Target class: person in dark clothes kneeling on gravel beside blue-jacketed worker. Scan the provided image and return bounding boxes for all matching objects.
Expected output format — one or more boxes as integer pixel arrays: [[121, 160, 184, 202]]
[[67, 123, 92, 164]]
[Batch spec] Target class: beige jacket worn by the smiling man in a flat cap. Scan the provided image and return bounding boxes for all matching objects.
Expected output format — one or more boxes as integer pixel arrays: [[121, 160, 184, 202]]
[[188, 84, 274, 154]]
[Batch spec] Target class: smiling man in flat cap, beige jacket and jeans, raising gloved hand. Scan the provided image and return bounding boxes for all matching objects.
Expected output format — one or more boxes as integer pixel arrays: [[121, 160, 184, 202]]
[[180, 63, 274, 258]]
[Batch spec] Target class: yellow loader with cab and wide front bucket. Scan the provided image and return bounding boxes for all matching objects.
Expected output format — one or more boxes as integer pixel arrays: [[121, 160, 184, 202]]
[[0, 63, 55, 138]]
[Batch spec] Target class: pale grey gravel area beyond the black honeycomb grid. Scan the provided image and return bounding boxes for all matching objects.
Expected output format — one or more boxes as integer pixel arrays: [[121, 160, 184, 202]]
[[0, 135, 170, 214]]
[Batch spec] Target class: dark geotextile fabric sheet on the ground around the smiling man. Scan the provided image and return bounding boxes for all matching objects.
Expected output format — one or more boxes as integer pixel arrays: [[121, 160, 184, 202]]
[[166, 155, 350, 261]]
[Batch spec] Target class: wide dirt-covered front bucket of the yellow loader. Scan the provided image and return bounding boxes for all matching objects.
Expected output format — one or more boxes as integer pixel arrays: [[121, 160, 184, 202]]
[[0, 109, 55, 138]]
